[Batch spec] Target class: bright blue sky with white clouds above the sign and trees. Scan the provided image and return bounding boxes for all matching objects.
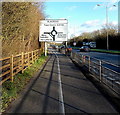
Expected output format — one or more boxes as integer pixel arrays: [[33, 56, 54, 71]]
[[44, 0, 118, 39]]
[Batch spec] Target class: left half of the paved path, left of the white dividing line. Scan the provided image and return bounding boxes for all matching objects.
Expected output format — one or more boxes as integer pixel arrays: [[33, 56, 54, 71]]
[[7, 56, 59, 113]]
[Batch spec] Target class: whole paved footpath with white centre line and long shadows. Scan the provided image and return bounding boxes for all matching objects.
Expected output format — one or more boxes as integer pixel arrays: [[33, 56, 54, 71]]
[[6, 52, 117, 114]]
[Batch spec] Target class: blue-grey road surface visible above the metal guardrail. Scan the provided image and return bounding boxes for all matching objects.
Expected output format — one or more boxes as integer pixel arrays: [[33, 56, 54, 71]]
[[74, 50, 120, 66]]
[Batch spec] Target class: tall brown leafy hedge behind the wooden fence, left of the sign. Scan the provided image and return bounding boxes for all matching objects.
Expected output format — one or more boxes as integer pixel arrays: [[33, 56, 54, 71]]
[[0, 2, 45, 58]]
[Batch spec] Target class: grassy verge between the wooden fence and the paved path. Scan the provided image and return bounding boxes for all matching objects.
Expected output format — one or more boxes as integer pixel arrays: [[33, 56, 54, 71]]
[[0, 56, 47, 112]]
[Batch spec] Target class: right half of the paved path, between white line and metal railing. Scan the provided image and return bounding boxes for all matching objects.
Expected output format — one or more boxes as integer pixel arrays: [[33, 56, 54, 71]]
[[59, 53, 116, 114]]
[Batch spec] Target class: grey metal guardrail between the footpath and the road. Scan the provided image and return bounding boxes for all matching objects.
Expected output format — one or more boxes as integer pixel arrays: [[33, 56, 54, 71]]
[[70, 51, 120, 94]]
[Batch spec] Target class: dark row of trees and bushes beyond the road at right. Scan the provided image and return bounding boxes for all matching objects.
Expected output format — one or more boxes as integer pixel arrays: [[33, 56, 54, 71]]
[[68, 24, 120, 50]]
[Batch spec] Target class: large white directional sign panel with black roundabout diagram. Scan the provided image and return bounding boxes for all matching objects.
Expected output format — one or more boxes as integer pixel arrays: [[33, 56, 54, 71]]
[[39, 19, 68, 42]]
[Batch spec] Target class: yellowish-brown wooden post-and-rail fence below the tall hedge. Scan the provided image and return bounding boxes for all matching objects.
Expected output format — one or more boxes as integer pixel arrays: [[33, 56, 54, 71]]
[[0, 49, 43, 85]]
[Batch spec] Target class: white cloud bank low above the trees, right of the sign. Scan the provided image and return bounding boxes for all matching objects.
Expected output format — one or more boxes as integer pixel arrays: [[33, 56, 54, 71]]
[[68, 19, 118, 39]]
